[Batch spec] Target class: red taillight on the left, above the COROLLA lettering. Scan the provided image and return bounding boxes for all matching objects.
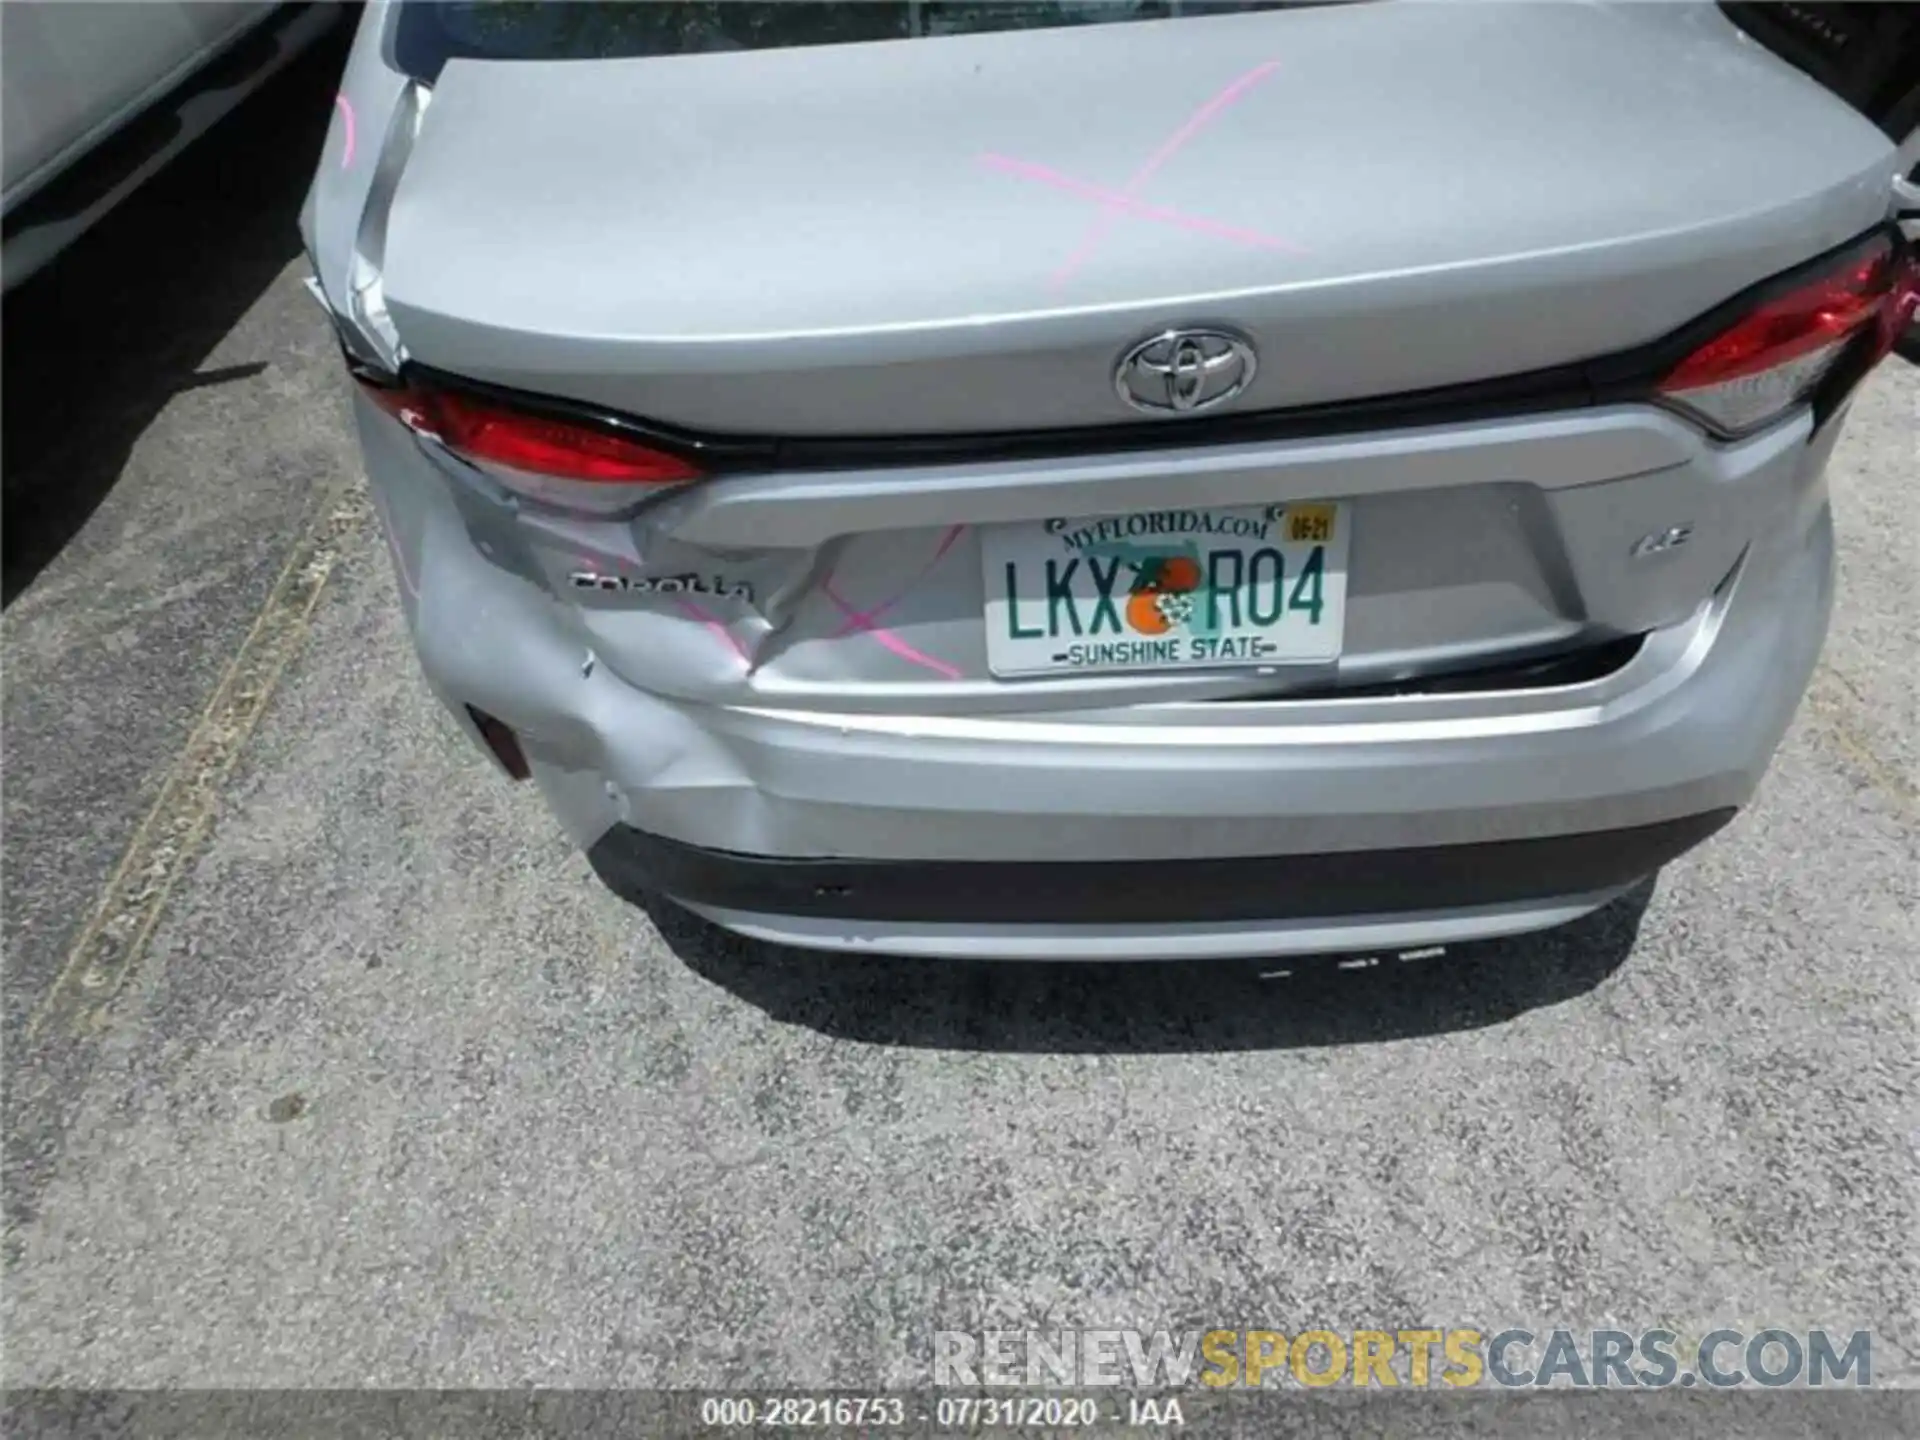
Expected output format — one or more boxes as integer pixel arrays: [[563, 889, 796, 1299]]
[[367, 384, 701, 486]]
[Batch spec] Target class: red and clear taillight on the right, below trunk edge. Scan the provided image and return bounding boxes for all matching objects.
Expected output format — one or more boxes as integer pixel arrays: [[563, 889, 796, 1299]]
[[1659, 236, 1910, 436]]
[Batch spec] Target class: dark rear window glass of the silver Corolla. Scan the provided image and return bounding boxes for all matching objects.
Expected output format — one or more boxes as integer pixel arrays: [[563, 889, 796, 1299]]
[[394, 0, 1298, 81]]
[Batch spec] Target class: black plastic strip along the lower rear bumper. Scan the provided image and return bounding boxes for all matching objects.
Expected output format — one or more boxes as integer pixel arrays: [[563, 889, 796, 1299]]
[[588, 808, 1734, 925]]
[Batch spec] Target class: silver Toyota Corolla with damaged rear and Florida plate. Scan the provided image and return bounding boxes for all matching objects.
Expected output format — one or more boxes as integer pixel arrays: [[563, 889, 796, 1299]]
[[303, 0, 1914, 971]]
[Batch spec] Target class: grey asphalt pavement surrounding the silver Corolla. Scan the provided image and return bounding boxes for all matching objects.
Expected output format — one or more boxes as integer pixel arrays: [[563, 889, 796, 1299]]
[[4, 36, 1920, 1436]]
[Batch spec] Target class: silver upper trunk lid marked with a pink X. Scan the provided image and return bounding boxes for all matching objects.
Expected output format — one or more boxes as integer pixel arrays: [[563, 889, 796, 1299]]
[[382, 4, 1885, 436]]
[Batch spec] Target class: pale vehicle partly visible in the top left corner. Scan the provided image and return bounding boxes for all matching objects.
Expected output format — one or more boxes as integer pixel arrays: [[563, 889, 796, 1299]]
[[0, 0, 340, 288]]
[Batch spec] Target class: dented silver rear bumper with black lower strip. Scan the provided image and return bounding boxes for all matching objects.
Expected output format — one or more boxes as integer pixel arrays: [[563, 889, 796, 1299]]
[[369, 395, 1834, 958]]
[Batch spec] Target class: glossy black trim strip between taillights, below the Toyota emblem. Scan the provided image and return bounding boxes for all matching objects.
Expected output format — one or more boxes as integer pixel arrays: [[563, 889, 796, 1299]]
[[399, 225, 1907, 474]]
